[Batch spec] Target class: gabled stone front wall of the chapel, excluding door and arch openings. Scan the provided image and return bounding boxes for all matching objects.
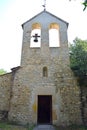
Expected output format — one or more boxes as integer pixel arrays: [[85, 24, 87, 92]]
[[9, 11, 82, 125]]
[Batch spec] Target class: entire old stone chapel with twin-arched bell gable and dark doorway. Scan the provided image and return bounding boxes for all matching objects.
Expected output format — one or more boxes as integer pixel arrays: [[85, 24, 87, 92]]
[[0, 10, 82, 125]]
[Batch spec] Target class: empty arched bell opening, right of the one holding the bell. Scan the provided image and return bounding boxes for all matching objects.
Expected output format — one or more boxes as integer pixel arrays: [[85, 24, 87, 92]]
[[49, 23, 60, 47]]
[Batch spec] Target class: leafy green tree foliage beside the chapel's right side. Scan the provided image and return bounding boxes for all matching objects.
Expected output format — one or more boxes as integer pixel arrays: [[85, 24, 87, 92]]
[[70, 38, 87, 77]]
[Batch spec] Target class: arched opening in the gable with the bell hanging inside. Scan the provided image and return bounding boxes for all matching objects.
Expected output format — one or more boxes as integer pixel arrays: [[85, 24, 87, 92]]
[[30, 23, 41, 47]]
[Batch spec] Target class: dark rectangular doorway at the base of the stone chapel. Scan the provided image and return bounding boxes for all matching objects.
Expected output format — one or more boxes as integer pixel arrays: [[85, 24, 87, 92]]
[[38, 95, 52, 124]]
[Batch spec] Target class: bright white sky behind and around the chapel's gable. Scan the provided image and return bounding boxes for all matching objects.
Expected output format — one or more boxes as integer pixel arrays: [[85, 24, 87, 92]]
[[0, 0, 87, 72]]
